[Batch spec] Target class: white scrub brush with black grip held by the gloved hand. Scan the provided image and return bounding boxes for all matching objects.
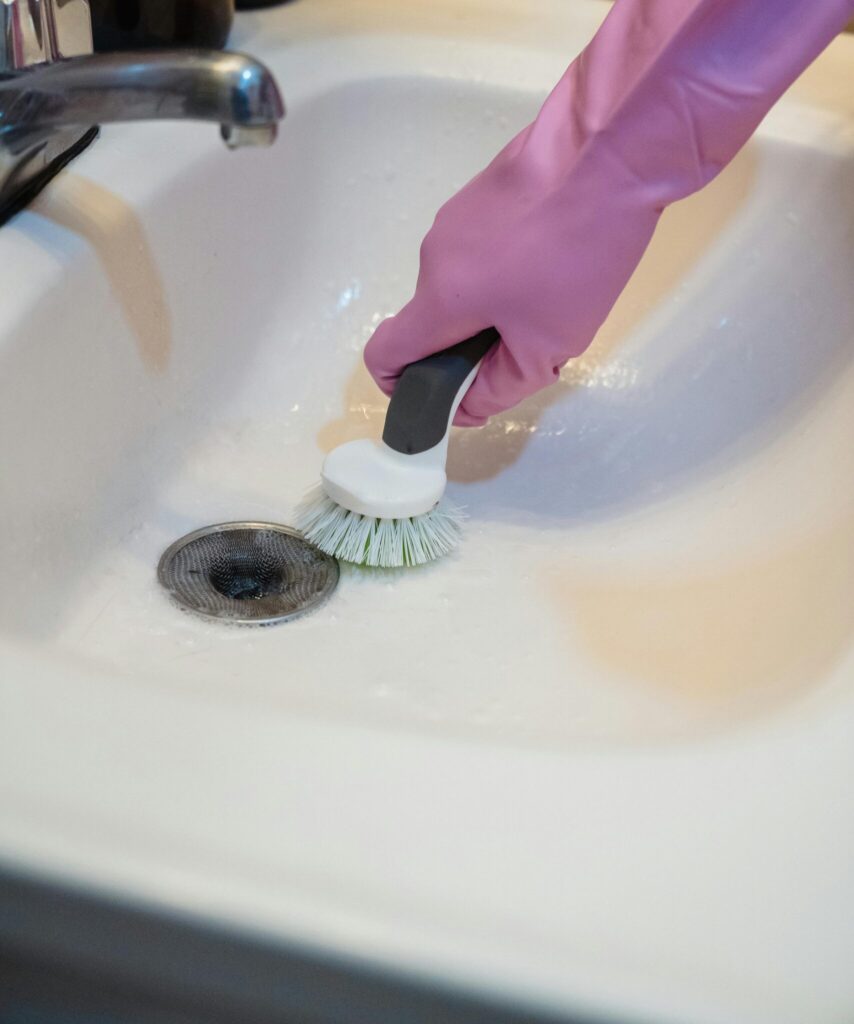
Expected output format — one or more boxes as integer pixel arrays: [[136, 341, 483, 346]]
[[297, 328, 499, 568]]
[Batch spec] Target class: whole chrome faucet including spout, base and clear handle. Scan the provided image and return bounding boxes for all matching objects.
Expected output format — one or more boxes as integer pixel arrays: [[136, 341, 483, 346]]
[[0, 0, 285, 223]]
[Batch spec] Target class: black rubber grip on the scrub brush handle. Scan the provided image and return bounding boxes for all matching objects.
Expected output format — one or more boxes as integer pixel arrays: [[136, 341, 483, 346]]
[[383, 327, 501, 455]]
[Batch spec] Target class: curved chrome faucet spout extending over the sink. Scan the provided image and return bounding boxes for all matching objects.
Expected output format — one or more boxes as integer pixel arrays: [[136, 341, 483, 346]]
[[0, 50, 285, 148]]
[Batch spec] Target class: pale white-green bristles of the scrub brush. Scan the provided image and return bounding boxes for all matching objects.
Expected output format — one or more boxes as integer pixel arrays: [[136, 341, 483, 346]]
[[297, 486, 463, 568]]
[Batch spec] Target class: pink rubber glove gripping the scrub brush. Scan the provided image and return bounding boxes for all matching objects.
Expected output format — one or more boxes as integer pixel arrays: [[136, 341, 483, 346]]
[[365, 0, 854, 426]]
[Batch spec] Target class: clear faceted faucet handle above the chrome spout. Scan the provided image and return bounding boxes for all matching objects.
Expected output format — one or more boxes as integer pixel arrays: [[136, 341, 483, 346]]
[[0, 0, 92, 72]]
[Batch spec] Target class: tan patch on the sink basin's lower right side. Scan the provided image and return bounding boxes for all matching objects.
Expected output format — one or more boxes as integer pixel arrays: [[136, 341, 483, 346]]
[[550, 518, 854, 719]]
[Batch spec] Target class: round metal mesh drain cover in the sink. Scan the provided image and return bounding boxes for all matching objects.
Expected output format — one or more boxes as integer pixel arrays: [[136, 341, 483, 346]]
[[158, 522, 338, 626]]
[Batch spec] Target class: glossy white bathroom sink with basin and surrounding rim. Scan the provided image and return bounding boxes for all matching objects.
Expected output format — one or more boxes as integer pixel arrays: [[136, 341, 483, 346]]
[[0, 0, 854, 1024]]
